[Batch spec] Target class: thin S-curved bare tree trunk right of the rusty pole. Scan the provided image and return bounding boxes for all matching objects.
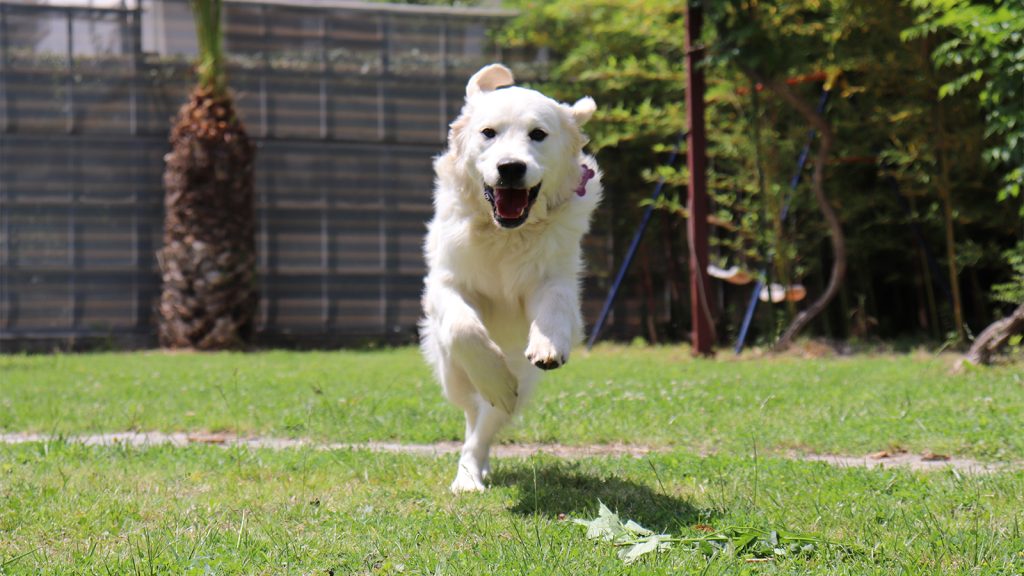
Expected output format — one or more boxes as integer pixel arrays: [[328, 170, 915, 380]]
[[764, 79, 846, 352]]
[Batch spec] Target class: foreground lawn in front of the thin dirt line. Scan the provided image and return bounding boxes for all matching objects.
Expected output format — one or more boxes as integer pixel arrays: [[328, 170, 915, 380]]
[[0, 442, 1024, 575]]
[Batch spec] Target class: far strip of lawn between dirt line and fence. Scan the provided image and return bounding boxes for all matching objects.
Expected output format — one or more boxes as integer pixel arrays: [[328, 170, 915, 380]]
[[0, 346, 1024, 460]]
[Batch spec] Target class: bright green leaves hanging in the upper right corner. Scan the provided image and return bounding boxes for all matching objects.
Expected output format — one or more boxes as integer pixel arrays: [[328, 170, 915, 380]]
[[903, 0, 1024, 211]]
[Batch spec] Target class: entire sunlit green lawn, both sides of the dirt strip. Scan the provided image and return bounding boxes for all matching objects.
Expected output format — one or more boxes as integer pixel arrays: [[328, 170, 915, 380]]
[[0, 346, 1024, 576]]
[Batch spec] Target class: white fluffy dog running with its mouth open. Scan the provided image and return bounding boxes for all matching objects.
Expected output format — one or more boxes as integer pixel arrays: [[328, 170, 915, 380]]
[[420, 65, 601, 492]]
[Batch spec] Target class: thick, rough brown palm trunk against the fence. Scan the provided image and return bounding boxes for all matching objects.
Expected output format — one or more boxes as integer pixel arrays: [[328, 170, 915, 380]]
[[157, 84, 258, 349]]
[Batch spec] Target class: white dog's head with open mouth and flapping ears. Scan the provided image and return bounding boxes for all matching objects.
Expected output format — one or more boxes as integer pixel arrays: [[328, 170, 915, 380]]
[[446, 64, 596, 229]]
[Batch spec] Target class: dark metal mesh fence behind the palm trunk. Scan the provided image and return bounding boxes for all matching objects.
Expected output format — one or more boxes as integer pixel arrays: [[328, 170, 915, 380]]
[[0, 0, 573, 349]]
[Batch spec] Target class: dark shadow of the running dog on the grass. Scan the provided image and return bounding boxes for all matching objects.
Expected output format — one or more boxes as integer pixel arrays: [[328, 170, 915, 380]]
[[492, 458, 718, 530]]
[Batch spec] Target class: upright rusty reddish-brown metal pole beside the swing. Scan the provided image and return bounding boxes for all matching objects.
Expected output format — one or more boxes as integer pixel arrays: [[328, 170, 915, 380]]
[[685, 0, 715, 356]]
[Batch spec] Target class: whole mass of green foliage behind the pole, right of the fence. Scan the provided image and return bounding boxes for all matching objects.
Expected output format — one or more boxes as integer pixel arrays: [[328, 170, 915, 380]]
[[503, 0, 1024, 338]]
